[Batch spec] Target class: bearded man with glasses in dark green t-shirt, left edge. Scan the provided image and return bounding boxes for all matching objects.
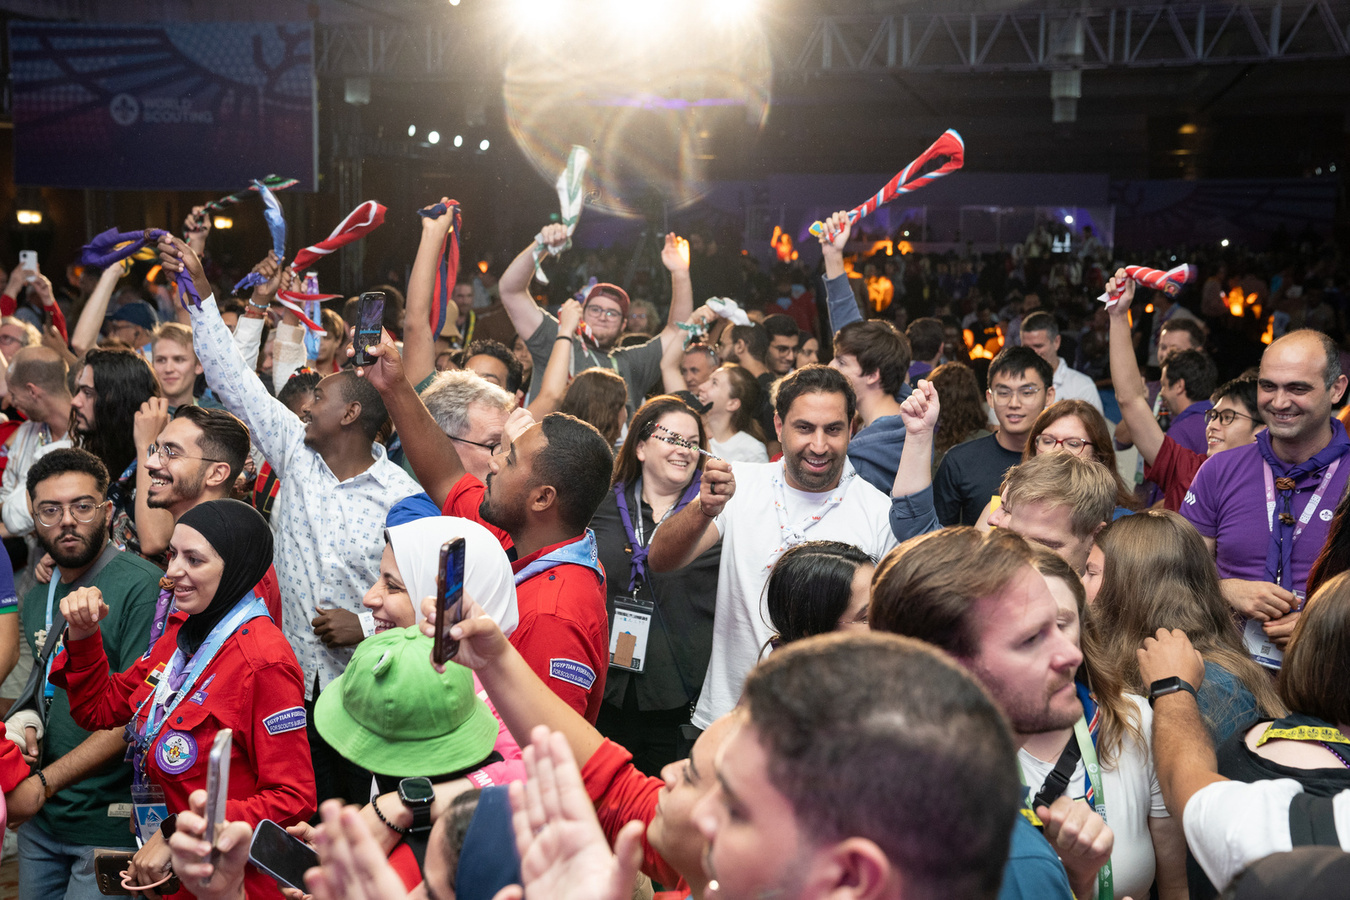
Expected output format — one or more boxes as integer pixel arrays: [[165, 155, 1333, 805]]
[[7, 448, 161, 897]]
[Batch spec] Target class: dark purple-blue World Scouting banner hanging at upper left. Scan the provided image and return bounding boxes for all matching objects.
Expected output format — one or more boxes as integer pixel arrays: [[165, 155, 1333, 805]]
[[9, 22, 319, 190]]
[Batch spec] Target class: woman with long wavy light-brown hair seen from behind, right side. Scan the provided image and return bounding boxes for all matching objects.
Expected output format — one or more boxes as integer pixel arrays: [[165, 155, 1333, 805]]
[[1092, 510, 1284, 742]]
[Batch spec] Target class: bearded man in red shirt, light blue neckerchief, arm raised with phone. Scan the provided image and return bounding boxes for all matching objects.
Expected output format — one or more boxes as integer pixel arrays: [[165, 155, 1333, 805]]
[[360, 337, 614, 725]]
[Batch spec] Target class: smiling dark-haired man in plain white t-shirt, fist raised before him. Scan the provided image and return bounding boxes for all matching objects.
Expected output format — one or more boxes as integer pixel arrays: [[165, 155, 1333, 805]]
[[648, 366, 895, 729]]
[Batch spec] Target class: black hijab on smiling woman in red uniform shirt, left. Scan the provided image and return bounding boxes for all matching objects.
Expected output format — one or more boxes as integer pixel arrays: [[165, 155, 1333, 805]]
[[178, 501, 271, 657]]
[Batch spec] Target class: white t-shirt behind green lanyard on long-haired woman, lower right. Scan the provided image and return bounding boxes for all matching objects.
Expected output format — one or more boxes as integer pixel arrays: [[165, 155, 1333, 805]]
[[1017, 694, 1169, 900]]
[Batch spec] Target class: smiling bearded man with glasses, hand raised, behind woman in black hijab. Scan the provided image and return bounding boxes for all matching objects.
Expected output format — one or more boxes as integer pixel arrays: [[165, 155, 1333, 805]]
[[136, 407, 282, 626]]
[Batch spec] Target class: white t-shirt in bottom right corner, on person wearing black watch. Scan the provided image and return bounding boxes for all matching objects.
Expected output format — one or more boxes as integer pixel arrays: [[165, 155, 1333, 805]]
[[1181, 779, 1350, 891]]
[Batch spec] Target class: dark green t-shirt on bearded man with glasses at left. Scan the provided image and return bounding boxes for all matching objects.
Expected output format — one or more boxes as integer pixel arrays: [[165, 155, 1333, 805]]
[[19, 551, 163, 849]]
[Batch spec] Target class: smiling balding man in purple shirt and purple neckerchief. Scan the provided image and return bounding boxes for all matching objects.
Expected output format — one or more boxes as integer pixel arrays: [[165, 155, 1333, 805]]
[[1181, 329, 1350, 668]]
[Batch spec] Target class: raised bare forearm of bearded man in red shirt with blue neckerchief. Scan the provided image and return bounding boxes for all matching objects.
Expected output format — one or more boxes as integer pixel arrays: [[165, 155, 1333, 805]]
[[356, 336, 464, 506]]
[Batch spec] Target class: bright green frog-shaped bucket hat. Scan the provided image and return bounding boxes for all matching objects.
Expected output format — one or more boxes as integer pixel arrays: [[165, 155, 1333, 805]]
[[315, 626, 497, 777]]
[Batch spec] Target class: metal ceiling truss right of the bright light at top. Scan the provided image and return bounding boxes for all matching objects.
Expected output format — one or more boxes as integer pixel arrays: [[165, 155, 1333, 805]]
[[778, 0, 1350, 74]]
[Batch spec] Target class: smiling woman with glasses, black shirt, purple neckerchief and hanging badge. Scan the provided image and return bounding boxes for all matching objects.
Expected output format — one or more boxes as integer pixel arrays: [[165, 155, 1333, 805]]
[[591, 394, 722, 776]]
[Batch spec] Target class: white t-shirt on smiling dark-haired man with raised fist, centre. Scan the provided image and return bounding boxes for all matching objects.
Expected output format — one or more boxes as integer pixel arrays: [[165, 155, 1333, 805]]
[[694, 460, 896, 729]]
